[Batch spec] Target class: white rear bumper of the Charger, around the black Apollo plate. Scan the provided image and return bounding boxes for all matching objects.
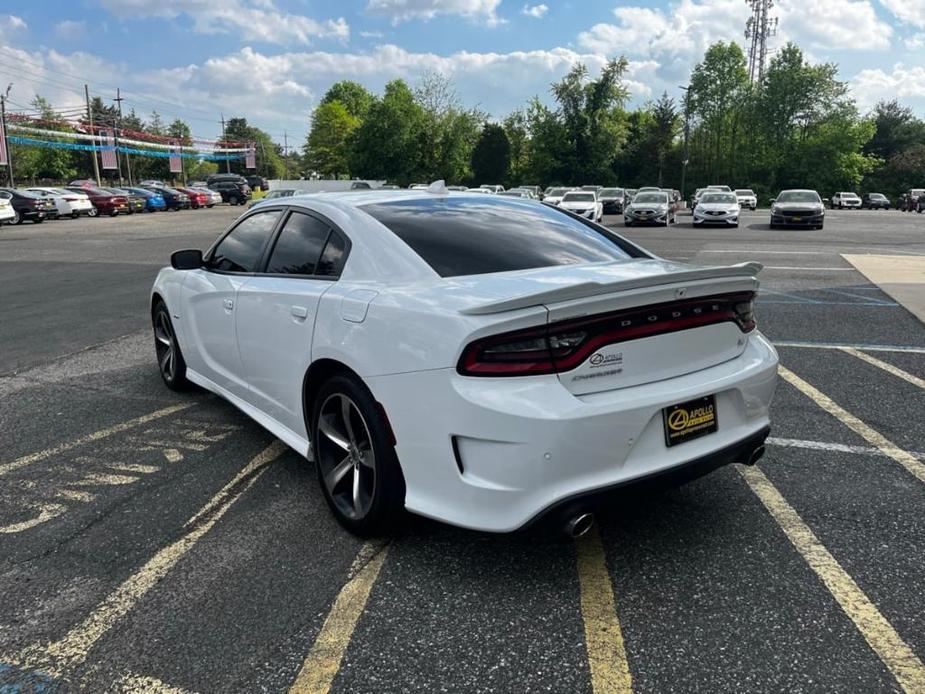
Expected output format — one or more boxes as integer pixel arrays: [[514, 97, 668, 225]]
[[367, 333, 777, 532]]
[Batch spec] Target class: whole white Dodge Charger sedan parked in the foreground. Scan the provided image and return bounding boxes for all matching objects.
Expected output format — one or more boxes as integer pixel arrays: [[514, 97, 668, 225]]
[[151, 190, 777, 534]]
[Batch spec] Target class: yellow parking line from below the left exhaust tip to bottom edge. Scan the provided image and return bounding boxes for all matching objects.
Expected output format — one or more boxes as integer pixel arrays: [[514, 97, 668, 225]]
[[576, 528, 633, 694]]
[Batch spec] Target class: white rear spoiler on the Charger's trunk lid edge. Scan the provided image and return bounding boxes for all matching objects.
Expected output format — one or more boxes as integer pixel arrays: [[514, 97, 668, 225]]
[[460, 262, 764, 316]]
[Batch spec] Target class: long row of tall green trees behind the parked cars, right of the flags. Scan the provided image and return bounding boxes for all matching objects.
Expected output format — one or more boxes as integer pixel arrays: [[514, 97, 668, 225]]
[[302, 42, 925, 199]]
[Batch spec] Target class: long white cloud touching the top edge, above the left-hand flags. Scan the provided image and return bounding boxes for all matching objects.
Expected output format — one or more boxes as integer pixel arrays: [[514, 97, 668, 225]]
[[102, 0, 350, 44]]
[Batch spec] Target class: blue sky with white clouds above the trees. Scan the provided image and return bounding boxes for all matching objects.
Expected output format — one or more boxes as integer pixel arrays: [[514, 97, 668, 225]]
[[0, 0, 925, 144]]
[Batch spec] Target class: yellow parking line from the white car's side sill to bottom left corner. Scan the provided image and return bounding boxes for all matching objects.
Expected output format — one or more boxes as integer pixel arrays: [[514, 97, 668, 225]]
[[14, 441, 287, 675]]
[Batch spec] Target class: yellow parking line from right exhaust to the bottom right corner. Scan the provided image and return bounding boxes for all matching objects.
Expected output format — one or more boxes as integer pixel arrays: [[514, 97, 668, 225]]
[[739, 467, 925, 694]]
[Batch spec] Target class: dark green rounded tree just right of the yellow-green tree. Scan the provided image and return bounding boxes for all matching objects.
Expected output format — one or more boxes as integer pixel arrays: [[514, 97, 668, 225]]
[[348, 80, 425, 185]]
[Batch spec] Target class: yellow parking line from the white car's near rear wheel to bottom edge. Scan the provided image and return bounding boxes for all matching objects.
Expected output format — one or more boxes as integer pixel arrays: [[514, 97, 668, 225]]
[[289, 544, 388, 694]]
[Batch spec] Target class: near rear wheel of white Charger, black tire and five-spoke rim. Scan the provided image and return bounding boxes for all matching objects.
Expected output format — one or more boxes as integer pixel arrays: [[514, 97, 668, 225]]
[[309, 374, 405, 537]]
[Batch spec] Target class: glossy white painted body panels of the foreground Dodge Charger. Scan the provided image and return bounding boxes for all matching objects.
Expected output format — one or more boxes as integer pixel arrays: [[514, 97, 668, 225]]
[[153, 191, 777, 532]]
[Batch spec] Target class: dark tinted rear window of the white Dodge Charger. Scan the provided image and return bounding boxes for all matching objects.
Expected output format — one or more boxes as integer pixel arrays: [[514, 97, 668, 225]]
[[361, 196, 639, 277]]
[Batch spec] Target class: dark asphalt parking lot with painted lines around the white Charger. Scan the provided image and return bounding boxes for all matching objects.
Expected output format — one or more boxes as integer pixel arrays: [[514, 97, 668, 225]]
[[0, 206, 925, 694]]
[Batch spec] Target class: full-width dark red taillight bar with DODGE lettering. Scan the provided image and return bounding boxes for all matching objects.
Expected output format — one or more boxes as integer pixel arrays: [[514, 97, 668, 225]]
[[456, 292, 756, 376]]
